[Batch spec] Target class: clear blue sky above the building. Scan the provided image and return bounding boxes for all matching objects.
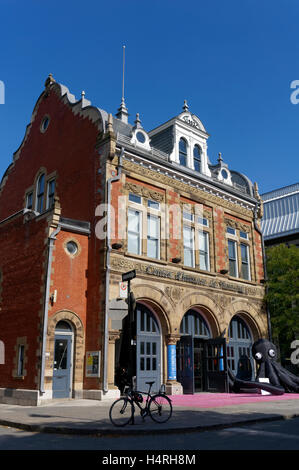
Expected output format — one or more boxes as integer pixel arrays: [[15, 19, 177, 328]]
[[0, 0, 299, 193]]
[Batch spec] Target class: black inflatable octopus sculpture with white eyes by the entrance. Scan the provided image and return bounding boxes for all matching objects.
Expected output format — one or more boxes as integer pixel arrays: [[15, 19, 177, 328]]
[[228, 339, 299, 395]]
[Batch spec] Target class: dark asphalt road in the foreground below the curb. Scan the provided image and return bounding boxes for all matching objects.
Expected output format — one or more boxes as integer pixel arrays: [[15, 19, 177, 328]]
[[0, 418, 299, 452]]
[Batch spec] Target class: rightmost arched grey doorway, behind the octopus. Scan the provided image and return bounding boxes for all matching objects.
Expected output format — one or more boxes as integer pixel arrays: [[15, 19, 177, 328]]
[[227, 315, 254, 380]]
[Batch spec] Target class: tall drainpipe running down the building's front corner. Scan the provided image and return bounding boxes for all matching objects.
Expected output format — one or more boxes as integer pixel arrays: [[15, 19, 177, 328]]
[[103, 147, 124, 393]]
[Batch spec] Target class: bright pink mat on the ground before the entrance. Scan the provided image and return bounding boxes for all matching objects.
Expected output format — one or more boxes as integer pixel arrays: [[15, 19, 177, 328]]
[[170, 393, 299, 408]]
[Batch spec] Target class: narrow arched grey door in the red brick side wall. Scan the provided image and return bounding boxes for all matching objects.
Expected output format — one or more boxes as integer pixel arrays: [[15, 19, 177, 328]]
[[53, 320, 74, 398]]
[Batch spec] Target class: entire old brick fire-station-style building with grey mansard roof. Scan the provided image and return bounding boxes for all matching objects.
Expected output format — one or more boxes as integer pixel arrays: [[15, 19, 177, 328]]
[[0, 75, 268, 404]]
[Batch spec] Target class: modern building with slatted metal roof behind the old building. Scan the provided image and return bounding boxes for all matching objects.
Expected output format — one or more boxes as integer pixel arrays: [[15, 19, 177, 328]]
[[261, 183, 299, 247]]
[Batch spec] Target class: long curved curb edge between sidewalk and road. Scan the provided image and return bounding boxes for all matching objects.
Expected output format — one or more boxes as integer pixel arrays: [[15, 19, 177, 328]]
[[0, 414, 299, 437]]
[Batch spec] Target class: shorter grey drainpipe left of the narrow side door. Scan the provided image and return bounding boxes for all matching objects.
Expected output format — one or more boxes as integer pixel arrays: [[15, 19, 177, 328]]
[[40, 225, 61, 393]]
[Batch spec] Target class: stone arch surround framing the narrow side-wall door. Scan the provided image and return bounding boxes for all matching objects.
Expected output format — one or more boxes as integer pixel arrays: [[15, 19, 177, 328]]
[[45, 310, 85, 398]]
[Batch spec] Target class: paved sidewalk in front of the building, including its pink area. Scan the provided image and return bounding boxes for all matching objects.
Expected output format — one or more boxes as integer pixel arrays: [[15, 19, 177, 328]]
[[0, 393, 299, 436]]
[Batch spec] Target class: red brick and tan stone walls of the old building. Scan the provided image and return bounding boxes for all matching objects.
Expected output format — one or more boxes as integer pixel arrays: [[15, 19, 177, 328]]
[[0, 77, 267, 404]]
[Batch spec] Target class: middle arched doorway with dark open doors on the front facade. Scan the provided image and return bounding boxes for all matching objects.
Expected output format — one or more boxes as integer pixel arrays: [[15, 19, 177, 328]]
[[177, 309, 211, 393]]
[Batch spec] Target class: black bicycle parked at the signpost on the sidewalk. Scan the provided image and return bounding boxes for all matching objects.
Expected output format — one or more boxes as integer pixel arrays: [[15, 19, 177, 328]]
[[109, 382, 172, 427]]
